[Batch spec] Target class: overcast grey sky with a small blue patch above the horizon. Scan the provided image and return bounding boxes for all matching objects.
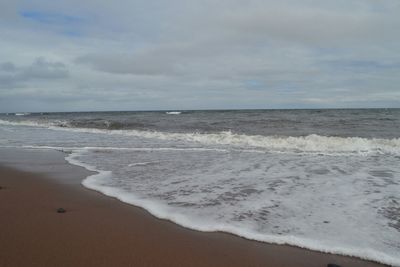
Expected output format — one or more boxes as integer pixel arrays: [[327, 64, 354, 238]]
[[0, 0, 400, 112]]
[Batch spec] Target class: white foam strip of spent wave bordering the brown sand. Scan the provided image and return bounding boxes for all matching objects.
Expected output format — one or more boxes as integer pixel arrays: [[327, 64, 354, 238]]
[[62, 149, 400, 266]]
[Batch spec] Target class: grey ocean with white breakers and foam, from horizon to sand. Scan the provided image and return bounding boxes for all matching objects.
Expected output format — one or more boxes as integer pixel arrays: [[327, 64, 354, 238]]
[[0, 109, 400, 266]]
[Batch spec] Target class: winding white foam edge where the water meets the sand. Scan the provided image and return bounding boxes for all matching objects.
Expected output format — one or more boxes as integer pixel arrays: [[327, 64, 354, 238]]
[[62, 149, 400, 266]]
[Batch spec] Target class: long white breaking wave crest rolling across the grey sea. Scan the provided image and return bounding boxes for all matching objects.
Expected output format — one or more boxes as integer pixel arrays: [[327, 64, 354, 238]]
[[0, 120, 400, 154]]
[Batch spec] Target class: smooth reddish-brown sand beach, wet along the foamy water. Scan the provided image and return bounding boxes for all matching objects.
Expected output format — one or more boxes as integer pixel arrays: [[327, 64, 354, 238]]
[[0, 149, 386, 267]]
